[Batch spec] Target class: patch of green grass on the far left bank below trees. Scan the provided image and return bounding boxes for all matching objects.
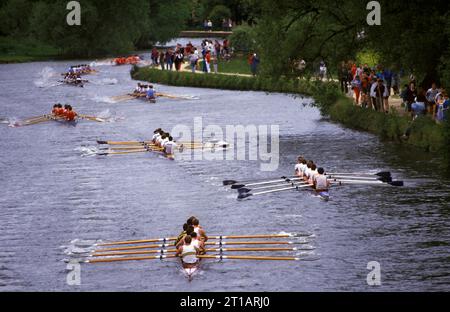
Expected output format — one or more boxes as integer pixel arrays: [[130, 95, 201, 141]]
[[0, 37, 59, 63]]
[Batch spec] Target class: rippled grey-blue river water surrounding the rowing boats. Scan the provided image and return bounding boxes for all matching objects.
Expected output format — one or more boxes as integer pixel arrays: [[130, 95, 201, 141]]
[[0, 57, 450, 291]]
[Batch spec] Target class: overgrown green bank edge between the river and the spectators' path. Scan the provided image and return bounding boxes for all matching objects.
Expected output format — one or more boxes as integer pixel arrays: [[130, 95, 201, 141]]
[[131, 66, 450, 158]]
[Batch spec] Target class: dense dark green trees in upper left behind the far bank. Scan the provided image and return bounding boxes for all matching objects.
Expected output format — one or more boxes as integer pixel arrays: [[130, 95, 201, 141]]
[[0, 0, 190, 56]]
